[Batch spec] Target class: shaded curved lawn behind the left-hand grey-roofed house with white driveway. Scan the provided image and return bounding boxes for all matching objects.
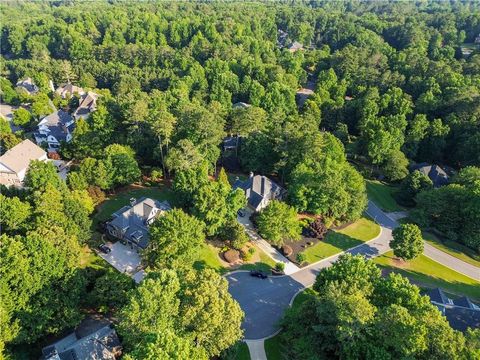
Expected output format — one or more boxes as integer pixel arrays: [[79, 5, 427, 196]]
[[93, 185, 175, 228]]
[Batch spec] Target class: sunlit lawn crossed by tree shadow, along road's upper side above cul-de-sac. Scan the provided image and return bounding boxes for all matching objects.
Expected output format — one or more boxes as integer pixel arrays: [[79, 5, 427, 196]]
[[304, 217, 380, 264]]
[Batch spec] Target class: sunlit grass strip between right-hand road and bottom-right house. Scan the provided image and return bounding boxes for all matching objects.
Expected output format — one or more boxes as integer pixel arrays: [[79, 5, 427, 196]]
[[374, 251, 480, 301]]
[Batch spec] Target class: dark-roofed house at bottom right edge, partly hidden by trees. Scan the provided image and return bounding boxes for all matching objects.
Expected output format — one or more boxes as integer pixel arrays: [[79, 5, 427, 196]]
[[428, 288, 480, 331]]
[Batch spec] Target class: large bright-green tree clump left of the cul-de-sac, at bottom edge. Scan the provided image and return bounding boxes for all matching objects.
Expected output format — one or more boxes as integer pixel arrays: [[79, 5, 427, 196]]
[[118, 270, 243, 359]]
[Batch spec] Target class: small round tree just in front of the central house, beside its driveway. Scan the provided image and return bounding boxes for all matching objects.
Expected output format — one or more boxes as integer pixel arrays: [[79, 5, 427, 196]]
[[257, 200, 302, 246]]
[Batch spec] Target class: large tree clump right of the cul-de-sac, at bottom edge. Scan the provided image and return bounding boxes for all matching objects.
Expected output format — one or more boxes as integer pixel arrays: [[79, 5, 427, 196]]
[[279, 255, 476, 359]]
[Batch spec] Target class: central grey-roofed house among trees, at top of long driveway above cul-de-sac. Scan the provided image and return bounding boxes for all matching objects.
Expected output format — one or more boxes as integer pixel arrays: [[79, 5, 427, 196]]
[[233, 173, 285, 211]]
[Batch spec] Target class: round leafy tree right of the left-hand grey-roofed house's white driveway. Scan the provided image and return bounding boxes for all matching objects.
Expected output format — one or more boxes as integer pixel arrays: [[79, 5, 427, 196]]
[[144, 209, 205, 268]]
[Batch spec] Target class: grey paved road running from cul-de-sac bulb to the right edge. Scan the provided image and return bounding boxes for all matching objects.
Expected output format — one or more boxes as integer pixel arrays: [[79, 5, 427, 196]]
[[227, 202, 480, 340]]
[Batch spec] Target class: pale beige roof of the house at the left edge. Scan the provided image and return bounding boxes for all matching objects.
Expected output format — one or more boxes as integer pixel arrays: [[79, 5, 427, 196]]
[[0, 139, 47, 173]]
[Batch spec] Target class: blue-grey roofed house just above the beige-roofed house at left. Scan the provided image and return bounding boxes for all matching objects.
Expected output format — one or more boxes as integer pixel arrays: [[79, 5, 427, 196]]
[[34, 110, 75, 151]]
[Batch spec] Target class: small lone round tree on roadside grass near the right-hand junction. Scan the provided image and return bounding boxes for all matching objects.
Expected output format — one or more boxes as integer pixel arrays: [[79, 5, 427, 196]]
[[390, 224, 423, 260]]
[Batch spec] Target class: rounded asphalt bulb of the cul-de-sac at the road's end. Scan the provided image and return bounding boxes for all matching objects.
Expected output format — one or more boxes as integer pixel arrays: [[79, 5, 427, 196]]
[[226, 271, 303, 339]]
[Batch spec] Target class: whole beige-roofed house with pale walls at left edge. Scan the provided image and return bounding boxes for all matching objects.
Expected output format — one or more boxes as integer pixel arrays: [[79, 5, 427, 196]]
[[0, 140, 47, 187]]
